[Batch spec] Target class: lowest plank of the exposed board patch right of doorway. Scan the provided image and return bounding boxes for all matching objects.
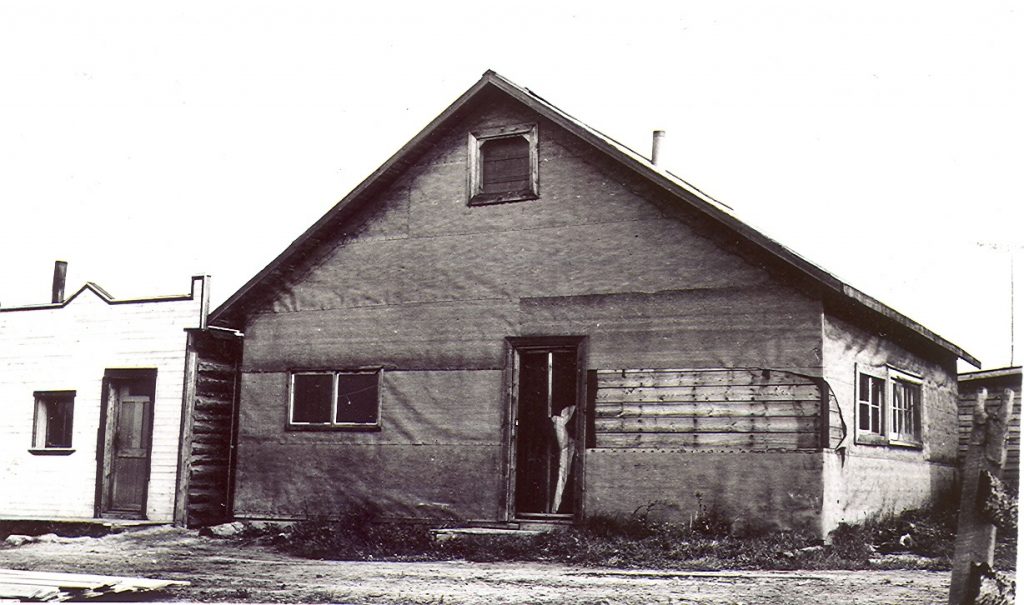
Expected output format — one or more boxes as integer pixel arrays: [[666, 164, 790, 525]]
[[597, 432, 818, 450]]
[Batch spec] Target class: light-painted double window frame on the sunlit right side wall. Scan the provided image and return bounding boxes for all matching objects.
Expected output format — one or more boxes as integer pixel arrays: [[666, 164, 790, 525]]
[[854, 364, 925, 449]]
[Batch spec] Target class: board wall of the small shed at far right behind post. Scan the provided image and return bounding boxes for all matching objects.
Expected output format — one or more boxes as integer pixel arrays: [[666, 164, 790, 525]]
[[957, 368, 1022, 491]]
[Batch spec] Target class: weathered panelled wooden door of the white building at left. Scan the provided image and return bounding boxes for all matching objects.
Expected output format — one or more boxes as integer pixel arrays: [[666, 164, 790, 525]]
[[99, 379, 153, 519]]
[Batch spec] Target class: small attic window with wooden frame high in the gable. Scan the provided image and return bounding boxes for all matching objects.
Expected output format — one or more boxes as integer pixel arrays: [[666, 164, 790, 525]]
[[469, 124, 539, 206]]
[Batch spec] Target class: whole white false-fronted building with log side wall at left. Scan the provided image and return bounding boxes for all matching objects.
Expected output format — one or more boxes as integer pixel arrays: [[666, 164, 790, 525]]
[[0, 261, 234, 523]]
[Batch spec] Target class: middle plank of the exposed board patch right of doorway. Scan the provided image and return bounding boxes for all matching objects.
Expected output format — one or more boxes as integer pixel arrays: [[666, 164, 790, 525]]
[[594, 400, 818, 418]]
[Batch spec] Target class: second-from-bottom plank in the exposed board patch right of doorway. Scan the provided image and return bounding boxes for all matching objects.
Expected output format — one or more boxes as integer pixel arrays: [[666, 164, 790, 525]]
[[595, 417, 818, 439]]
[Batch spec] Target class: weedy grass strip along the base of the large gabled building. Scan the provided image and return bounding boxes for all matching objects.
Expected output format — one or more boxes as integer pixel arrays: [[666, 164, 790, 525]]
[[247, 499, 1016, 570]]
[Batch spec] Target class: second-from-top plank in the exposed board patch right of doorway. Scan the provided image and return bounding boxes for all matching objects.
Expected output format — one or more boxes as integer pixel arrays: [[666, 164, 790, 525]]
[[597, 383, 821, 403]]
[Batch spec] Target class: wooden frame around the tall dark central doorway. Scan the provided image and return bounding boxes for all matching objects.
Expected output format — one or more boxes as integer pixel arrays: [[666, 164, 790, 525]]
[[502, 336, 591, 522]]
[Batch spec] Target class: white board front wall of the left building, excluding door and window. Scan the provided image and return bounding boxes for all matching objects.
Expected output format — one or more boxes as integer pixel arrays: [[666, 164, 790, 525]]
[[0, 277, 203, 521]]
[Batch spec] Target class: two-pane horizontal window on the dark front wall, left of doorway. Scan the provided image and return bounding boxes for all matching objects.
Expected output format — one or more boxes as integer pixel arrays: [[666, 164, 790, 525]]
[[288, 371, 381, 428]]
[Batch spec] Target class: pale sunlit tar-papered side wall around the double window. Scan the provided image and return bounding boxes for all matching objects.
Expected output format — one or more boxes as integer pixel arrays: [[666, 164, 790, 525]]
[[822, 313, 957, 530]]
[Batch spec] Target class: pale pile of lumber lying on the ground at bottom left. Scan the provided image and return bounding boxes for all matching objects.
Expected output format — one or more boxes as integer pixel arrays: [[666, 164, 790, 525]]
[[0, 569, 188, 602]]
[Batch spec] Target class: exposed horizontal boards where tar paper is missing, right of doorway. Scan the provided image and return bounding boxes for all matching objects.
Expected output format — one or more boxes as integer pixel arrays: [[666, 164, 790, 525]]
[[593, 370, 821, 451]]
